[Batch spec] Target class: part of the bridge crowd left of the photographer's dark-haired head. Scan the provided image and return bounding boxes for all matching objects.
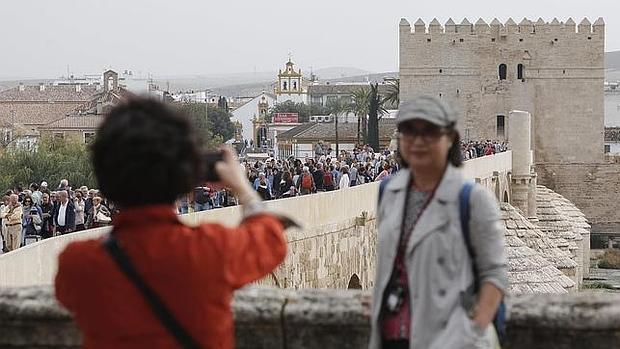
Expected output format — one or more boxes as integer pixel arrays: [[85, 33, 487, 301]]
[[0, 179, 115, 253]]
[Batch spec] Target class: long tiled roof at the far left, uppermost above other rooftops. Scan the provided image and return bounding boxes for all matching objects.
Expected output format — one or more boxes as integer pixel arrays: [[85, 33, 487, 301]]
[[0, 85, 98, 102]]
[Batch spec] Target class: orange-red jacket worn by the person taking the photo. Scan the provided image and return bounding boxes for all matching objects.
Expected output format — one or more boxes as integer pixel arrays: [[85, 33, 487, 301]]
[[56, 206, 286, 349]]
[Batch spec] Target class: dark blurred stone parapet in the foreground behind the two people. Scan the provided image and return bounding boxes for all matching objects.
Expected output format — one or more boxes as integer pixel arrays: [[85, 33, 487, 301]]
[[0, 287, 620, 349]]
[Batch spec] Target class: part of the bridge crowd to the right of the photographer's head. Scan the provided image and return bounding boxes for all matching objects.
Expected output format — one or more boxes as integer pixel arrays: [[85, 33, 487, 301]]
[[188, 140, 508, 213]]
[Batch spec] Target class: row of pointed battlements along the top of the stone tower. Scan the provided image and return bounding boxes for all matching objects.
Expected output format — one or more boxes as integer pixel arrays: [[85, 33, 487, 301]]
[[400, 17, 605, 38]]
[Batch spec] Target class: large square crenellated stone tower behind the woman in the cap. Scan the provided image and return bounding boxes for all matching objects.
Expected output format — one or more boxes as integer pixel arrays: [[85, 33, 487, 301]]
[[400, 18, 605, 164]]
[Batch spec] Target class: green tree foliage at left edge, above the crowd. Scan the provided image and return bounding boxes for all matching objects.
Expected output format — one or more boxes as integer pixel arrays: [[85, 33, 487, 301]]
[[0, 137, 97, 190]]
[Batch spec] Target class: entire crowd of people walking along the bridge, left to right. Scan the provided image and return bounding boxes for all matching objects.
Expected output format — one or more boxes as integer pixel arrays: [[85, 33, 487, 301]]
[[0, 140, 507, 252]]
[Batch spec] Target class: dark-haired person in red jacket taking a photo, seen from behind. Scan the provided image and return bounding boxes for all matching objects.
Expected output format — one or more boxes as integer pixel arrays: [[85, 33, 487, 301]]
[[55, 99, 291, 349]]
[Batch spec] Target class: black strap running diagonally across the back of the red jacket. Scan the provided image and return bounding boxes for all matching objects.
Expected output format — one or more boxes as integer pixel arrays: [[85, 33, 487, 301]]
[[103, 233, 200, 349]]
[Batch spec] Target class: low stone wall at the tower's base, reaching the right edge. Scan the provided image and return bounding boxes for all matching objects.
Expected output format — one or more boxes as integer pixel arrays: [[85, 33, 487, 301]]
[[536, 162, 620, 232]]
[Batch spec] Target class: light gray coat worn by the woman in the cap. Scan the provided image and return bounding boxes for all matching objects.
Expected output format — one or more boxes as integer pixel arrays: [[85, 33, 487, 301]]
[[369, 165, 508, 349]]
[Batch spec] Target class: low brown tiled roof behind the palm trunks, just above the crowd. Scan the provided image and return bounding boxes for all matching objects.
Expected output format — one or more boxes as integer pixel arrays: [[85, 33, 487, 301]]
[[278, 119, 396, 141]]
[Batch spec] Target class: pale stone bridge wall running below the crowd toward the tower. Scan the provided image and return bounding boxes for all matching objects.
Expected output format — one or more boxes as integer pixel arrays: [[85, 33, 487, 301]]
[[0, 151, 512, 289]]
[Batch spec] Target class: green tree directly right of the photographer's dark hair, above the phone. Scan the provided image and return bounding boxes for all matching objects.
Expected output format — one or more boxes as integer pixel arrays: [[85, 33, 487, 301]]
[[176, 103, 235, 149]]
